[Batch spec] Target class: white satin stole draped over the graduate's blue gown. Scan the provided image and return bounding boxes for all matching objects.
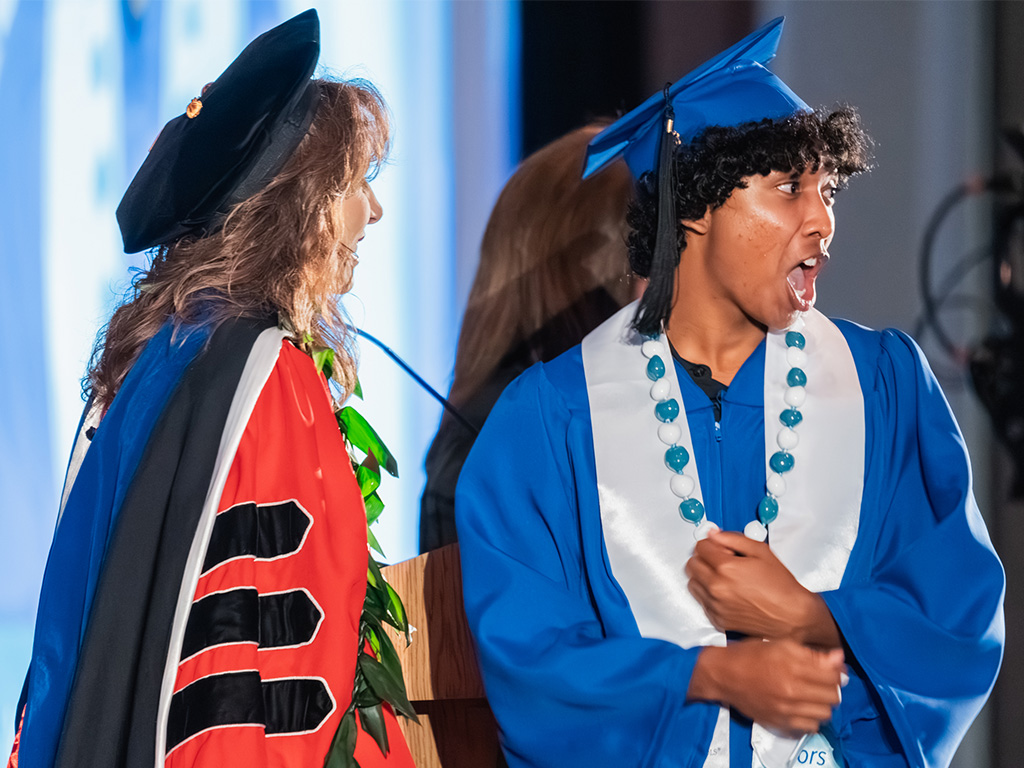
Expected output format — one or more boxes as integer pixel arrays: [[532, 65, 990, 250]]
[[583, 303, 864, 768]]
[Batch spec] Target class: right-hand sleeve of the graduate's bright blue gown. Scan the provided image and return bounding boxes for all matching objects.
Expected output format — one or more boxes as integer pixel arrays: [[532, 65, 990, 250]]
[[822, 331, 1005, 768]]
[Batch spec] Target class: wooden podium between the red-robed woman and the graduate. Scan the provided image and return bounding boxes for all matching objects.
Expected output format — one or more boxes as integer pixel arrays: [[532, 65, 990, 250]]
[[382, 544, 505, 768]]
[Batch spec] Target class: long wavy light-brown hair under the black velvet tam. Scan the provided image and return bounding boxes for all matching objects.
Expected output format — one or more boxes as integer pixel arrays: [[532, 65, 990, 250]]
[[84, 80, 390, 409]]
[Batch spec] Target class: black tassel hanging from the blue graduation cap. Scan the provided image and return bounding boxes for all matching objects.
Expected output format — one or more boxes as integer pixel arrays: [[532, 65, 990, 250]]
[[633, 84, 679, 336]]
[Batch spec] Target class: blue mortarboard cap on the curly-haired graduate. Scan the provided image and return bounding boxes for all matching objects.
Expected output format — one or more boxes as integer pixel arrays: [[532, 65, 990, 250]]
[[583, 16, 811, 178]]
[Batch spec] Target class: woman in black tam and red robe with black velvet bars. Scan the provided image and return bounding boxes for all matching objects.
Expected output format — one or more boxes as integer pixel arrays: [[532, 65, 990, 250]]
[[9, 10, 412, 768]]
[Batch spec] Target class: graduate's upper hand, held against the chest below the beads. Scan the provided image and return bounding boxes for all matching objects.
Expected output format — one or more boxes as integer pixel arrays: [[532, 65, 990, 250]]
[[686, 531, 841, 648]]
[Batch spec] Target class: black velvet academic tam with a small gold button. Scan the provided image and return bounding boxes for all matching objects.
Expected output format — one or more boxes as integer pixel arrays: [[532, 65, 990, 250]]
[[117, 8, 319, 253]]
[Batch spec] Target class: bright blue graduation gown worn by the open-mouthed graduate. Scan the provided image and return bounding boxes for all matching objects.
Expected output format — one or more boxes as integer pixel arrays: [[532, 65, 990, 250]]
[[457, 322, 1005, 768]]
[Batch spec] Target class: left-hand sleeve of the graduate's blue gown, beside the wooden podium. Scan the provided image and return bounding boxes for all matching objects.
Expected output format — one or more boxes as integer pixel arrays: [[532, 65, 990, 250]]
[[456, 366, 718, 768]]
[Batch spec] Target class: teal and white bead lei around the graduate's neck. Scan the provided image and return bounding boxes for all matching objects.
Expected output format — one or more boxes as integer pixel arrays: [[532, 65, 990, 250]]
[[641, 318, 807, 542]]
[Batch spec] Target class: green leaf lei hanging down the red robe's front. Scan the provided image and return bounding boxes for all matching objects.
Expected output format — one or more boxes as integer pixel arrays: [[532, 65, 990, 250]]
[[302, 335, 419, 768]]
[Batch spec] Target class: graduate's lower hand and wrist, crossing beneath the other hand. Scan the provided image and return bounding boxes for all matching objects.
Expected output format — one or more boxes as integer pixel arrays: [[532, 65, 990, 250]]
[[686, 639, 844, 736]]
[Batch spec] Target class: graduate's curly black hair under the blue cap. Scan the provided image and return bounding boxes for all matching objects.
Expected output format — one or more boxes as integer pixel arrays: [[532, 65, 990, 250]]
[[626, 106, 871, 334]]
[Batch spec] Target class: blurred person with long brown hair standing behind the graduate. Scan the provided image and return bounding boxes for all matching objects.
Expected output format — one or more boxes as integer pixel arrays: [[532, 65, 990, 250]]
[[420, 123, 637, 552]]
